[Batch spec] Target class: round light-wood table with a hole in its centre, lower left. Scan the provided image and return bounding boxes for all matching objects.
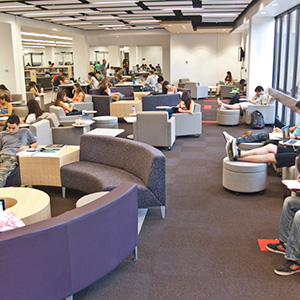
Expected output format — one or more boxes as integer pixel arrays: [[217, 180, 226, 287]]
[[0, 187, 51, 225]]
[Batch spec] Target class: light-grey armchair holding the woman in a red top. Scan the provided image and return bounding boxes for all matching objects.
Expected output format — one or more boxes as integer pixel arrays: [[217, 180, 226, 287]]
[[172, 103, 202, 136]]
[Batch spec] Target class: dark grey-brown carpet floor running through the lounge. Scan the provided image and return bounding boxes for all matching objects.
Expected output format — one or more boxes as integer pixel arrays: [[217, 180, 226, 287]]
[[43, 100, 300, 300]]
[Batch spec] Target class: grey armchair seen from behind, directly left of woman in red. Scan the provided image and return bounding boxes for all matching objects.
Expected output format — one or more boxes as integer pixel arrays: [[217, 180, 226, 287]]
[[133, 111, 175, 150]]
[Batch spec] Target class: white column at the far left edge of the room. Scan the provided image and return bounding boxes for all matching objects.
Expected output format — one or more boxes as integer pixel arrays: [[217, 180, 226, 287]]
[[0, 22, 26, 99]]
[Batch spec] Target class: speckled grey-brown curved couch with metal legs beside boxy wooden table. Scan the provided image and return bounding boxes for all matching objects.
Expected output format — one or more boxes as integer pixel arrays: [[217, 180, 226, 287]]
[[61, 134, 166, 218]]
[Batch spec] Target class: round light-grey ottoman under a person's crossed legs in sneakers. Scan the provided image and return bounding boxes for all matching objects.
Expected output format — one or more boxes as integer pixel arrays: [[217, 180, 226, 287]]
[[222, 157, 267, 193]]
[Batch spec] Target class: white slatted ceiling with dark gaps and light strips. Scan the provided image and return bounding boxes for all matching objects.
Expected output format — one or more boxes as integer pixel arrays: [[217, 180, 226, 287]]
[[0, 0, 256, 31]]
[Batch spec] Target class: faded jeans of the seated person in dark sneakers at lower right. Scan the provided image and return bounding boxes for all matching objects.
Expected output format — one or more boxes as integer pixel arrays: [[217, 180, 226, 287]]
[[279, 197, 300, 261]]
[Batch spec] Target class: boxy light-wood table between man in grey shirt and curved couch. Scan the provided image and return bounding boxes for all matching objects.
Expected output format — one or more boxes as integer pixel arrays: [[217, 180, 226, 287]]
[[19, 146, 79, 186]]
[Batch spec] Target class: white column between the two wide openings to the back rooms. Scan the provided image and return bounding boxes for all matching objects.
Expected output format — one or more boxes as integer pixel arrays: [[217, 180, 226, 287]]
[[73, 35, 90, 80]]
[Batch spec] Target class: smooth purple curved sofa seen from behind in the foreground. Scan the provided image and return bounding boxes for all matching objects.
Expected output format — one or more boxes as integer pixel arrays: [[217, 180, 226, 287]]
[[0, 183, 138, 300]]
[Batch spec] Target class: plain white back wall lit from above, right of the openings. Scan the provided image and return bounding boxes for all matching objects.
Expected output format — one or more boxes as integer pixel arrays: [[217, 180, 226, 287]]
[[170, 33, 242, 85]]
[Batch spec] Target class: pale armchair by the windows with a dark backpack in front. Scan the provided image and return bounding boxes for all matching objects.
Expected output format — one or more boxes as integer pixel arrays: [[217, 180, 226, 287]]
[[243, 99, 275, 124]]
